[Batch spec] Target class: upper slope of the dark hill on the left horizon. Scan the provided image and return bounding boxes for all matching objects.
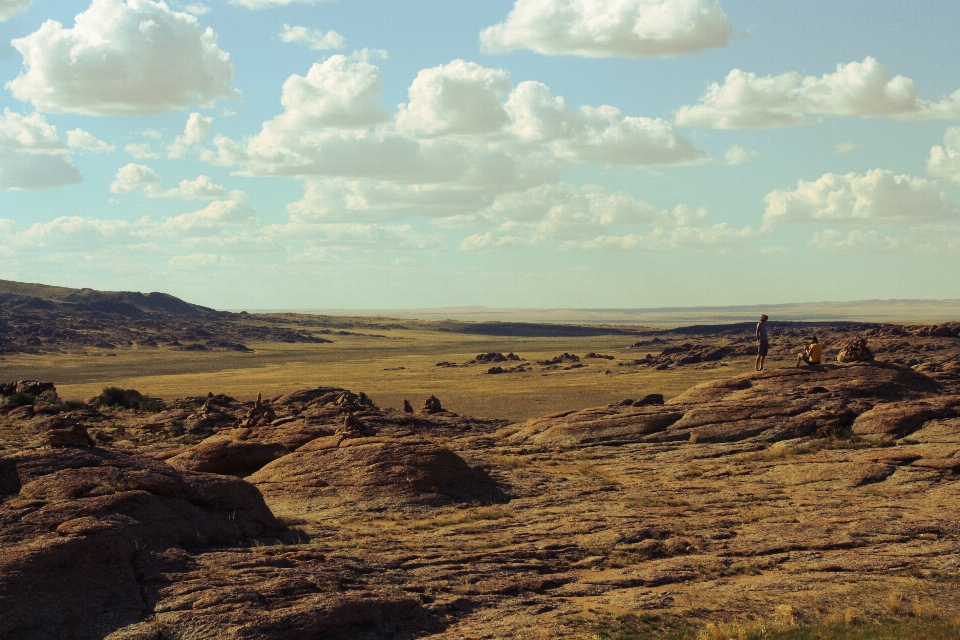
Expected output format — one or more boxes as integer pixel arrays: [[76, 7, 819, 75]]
[[0, 280, 218, 316]]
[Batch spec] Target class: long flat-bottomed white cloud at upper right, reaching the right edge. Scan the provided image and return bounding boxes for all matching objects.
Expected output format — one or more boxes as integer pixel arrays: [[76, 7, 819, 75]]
[[676, 56, 960, 129]]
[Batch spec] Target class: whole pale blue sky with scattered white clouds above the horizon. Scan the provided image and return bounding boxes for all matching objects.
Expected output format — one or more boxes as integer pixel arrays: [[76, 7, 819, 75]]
[[0, 0, 960, 309]]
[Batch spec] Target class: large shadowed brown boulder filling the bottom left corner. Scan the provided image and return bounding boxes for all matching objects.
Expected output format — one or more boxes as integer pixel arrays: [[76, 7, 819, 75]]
[[0, 448, 276, 640]]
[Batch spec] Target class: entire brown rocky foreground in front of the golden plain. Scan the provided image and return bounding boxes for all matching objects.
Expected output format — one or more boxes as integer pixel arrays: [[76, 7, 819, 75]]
[[0, 363, 960, 640]]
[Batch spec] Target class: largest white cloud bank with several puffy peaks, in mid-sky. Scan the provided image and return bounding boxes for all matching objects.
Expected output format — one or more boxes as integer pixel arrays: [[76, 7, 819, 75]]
[[221, 56, 706, 188]]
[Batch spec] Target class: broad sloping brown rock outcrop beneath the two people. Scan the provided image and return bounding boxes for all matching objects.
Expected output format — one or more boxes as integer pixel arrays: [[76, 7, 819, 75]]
[[503, 364, 940, 447]]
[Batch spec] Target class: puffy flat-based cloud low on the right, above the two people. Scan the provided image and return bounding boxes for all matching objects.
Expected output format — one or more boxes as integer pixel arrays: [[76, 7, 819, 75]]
[[763, 169, 960, 226]]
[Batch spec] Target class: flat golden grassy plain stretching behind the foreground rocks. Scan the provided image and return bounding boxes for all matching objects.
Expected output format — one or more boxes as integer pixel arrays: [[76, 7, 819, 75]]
[[0, 323, 753, 420]]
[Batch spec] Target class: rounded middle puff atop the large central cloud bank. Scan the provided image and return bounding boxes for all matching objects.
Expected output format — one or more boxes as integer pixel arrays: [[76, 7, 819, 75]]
[[397, 60, 512, 137]]
